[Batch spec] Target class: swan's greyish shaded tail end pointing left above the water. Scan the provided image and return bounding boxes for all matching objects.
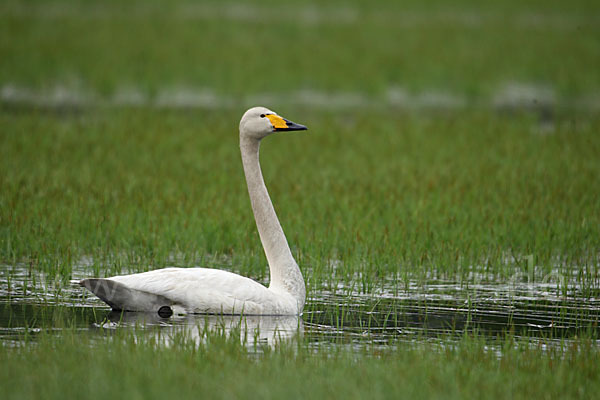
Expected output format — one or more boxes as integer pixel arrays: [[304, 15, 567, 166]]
[[79, 278, 173, 312]]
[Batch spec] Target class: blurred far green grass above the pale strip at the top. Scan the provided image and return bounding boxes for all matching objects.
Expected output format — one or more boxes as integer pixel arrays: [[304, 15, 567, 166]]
[[0, 0, 600, 96]]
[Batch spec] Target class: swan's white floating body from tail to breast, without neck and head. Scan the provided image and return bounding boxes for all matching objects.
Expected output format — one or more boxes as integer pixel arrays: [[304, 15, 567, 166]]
[[81, 268, 299, 315]]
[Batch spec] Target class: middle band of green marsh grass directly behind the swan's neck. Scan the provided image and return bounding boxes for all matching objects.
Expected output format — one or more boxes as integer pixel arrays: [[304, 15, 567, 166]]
[[0, 109, 600, 290]]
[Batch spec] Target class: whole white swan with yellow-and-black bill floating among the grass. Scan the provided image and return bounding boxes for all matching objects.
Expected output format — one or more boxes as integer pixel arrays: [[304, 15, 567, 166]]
[[79, 107, 307, 317]]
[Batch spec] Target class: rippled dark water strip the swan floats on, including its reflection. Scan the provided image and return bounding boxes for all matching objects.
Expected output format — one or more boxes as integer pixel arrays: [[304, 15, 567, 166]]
[[0, 266, 600, 348]]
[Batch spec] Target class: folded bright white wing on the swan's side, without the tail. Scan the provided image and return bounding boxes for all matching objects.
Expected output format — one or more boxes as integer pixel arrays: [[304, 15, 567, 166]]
[[103, 268, 273, 314]]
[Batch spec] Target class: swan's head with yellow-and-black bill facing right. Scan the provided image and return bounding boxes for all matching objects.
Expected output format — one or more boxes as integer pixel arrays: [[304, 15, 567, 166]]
[[240, 107, 308, 140]]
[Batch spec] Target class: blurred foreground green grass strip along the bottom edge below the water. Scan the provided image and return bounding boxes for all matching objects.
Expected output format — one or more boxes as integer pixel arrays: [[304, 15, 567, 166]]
[[0, 333, 600, 399]]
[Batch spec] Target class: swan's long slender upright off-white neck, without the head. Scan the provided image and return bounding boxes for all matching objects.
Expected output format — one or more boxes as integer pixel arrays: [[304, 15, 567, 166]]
[[240, 135, 306, 308]]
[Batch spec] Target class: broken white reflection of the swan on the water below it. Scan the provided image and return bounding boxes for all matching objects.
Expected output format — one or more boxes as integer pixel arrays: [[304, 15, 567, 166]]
[[96, 311, 304, 347]]
